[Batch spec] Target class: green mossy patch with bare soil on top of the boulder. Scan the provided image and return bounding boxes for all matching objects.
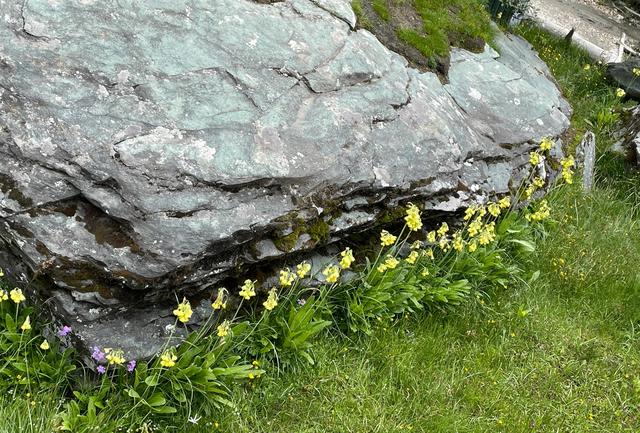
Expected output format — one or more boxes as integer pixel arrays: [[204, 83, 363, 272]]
[[352, 0, 494, 75]]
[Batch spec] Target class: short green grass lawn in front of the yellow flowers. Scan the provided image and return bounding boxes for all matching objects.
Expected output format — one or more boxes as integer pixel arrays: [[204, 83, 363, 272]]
[[0, 24, 640, 433]]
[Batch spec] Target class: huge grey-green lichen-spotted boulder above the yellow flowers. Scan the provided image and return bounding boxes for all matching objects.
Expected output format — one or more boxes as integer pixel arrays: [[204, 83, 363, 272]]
[[0, 0, 570, 356]]
